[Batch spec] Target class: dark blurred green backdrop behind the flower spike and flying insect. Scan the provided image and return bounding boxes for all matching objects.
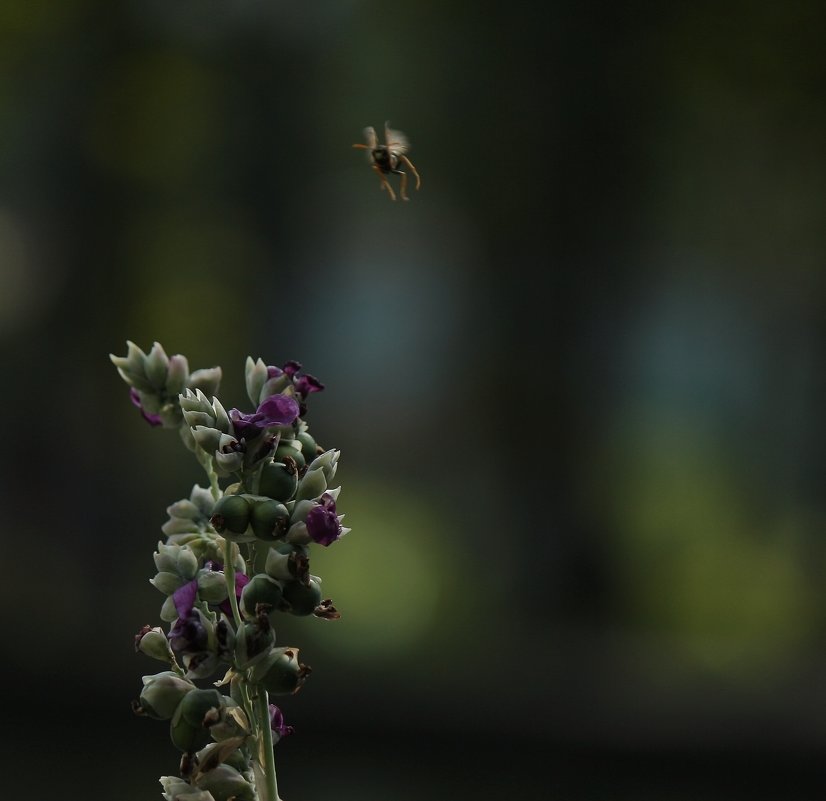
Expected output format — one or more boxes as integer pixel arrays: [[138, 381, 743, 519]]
[[0, 0, 826, 801]]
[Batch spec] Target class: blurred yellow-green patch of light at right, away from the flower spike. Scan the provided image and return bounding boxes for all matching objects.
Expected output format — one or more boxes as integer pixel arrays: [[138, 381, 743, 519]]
[[609, 421, 817, 675]]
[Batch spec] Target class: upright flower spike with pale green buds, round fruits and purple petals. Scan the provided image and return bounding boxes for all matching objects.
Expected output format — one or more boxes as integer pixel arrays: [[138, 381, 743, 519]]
[[111, 342, 349, 801]]
